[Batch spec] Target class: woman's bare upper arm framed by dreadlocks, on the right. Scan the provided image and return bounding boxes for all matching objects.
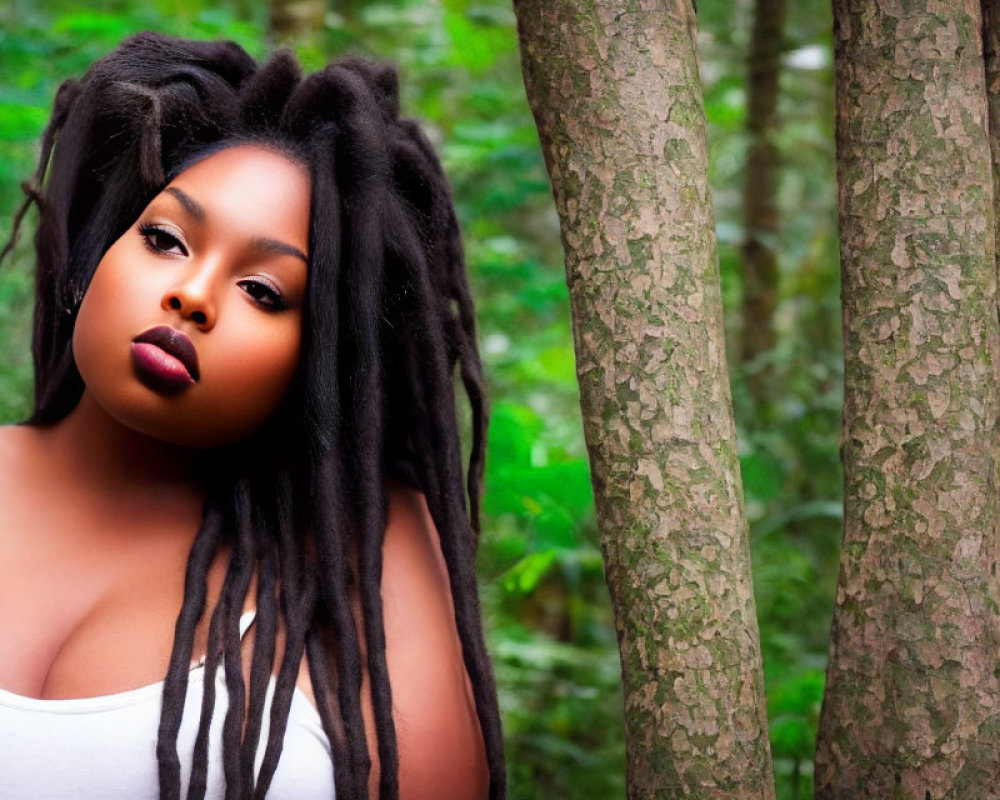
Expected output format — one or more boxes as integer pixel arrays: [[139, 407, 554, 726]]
[[382, 485, 488, 800]]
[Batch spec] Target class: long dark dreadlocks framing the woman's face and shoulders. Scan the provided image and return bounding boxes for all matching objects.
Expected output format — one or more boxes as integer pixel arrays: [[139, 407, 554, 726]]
[[0, 33, 504, 800]]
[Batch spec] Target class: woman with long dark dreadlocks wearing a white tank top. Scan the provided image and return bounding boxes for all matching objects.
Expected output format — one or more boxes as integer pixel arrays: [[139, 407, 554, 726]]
[[0, 34, 504, 800]]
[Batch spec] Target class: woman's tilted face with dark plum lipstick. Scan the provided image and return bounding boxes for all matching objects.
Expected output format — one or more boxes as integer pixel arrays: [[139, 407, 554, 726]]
[[73, 145, 310, 447]]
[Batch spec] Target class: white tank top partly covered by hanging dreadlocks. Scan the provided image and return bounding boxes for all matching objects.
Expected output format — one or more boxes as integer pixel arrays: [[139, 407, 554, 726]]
[[0, 612, 334, 800]]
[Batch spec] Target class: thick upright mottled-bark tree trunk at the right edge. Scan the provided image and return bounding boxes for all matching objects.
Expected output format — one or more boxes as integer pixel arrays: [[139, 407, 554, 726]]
[[816, 0, 1000, 800]]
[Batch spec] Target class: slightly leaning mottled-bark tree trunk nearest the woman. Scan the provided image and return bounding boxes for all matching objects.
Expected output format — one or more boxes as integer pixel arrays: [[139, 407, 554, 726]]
[[514, 0, 774, 800]]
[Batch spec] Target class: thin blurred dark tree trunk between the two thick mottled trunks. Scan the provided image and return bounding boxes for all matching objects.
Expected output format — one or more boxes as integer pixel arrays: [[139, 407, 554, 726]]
[[742, 0, 785, 409]]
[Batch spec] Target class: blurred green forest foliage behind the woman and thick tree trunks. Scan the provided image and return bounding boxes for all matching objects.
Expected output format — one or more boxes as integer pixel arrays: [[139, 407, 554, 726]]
[[0, 0, 842, 800]]
